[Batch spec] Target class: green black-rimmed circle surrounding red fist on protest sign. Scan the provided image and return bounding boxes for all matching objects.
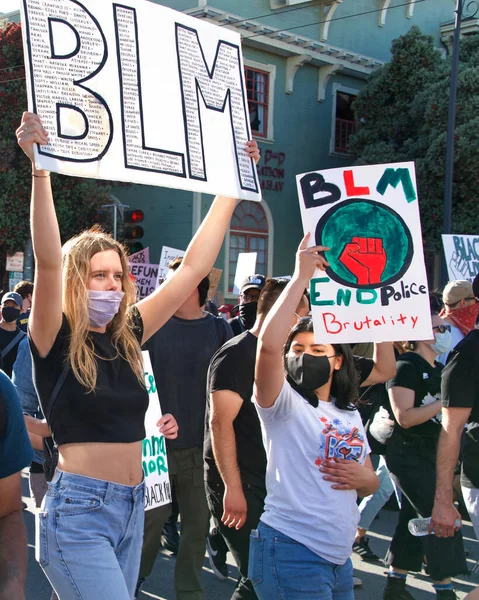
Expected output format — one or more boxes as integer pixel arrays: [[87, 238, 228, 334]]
[[316, 198, 413, 288]]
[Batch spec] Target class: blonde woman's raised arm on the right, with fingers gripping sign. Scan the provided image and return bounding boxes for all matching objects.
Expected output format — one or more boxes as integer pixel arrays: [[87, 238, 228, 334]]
[[137, 140, 259, 343]]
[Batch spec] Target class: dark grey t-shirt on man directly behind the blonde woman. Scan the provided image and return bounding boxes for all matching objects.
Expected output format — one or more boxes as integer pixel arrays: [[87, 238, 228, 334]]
[[145, 313, 233, 448]]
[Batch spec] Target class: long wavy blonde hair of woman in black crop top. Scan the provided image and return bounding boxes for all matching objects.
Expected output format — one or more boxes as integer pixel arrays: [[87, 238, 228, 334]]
[[62, 231, 144, 392]]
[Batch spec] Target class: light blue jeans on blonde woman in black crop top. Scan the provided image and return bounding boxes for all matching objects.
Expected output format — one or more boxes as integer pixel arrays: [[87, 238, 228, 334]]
[[36, 469, 144, 600]]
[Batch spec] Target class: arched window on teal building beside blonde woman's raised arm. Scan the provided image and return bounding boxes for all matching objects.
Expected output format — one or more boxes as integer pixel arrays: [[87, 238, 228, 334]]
[[228, 200, 269, 292]]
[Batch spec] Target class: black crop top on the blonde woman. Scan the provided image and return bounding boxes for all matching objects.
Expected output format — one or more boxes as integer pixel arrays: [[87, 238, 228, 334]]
[[29, 307, 148, 446]]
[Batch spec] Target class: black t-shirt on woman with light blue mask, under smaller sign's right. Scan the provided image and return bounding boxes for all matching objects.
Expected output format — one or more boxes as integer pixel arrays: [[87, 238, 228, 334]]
[[386, 352, 443, 446]]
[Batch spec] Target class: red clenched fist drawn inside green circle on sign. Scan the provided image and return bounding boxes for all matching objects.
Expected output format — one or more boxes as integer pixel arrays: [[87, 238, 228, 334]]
[[339, 237, 387, 285]]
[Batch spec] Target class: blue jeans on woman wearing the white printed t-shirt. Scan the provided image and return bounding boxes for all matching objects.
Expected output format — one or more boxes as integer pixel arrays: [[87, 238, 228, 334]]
[[248, 522, 354, 600]]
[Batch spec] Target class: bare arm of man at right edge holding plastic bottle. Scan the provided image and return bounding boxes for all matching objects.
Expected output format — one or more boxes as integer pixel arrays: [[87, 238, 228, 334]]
[[431, 407, 471, 537]]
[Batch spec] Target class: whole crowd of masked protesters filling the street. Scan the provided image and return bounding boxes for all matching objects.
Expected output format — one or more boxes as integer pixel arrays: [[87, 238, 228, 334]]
[[0, 113, 479, 600]]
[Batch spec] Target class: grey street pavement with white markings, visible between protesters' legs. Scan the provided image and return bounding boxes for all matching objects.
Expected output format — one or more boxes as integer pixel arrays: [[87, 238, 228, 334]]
[[23, 474, 479, 600]]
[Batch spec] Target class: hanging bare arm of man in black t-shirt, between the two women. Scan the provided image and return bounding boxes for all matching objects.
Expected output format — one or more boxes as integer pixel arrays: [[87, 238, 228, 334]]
[[210, 390, 247, 529]]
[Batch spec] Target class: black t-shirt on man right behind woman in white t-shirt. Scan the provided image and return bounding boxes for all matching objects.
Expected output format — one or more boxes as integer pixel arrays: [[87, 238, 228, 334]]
[[204, 331, 374, 490]]
